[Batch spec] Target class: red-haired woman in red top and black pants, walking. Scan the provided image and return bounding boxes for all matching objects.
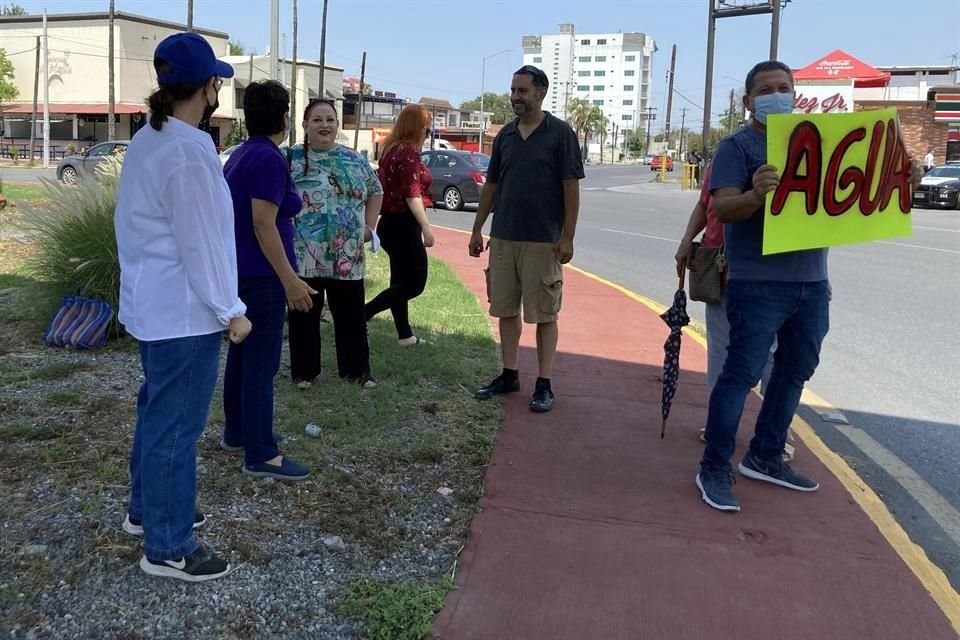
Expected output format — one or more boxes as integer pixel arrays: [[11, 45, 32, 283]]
[[366, 104, 433, 347]]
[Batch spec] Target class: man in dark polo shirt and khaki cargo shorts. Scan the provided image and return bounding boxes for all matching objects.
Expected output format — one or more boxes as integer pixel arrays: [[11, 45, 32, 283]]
[[470, 65, 583, 412]]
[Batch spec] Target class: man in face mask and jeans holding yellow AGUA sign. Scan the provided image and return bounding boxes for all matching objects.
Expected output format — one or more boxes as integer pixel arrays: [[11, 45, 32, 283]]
[[696, 60, 921, 511]]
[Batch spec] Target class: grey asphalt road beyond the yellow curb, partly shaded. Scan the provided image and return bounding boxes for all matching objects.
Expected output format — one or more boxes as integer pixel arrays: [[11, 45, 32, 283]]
[[431, 166, 960, 590]]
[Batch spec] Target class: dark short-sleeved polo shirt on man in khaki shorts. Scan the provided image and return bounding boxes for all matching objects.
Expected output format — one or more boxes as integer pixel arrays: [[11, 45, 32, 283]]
[[487, 112, 583, 242]]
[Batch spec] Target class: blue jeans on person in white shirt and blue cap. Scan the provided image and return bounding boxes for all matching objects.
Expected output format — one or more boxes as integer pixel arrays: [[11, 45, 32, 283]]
[[128, 332, 223, 560]]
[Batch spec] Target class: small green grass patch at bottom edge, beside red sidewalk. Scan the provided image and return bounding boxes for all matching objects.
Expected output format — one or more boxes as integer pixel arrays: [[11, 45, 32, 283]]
[[337, 578, 453, 640]]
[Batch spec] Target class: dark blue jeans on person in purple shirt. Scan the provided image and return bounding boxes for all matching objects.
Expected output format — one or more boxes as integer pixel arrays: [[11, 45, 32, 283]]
[[223, 276, 287, 465]]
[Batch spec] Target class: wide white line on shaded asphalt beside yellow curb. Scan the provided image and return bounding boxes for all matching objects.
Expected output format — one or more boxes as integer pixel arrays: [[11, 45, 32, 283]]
[[836, 425, 960, 544]]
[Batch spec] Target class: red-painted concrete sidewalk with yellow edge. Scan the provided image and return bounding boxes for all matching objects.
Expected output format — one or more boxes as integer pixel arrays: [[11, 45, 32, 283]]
[[431, 230, 960, 640]]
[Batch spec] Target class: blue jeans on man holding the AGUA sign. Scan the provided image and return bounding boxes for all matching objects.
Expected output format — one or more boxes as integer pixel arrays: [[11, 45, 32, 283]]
[[700, 280, 830, 469]]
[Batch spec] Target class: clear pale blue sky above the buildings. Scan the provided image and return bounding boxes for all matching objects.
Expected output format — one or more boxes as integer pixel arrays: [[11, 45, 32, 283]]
[[9, 0, 960, 132]]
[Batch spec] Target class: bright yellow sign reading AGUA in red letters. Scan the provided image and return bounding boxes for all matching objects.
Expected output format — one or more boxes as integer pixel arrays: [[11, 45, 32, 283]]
[[763, 109, 911, 255]]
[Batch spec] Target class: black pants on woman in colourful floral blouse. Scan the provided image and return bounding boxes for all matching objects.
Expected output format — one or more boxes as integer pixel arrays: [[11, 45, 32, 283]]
[[288, 278, 370, 382]]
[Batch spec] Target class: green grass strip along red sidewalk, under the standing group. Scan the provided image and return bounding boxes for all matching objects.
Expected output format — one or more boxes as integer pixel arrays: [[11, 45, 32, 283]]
[[248, 254, 502, 556]]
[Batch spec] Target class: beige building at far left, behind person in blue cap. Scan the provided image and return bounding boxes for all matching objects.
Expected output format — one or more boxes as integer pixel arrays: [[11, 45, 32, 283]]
[[0, 12, 234, 155]]
